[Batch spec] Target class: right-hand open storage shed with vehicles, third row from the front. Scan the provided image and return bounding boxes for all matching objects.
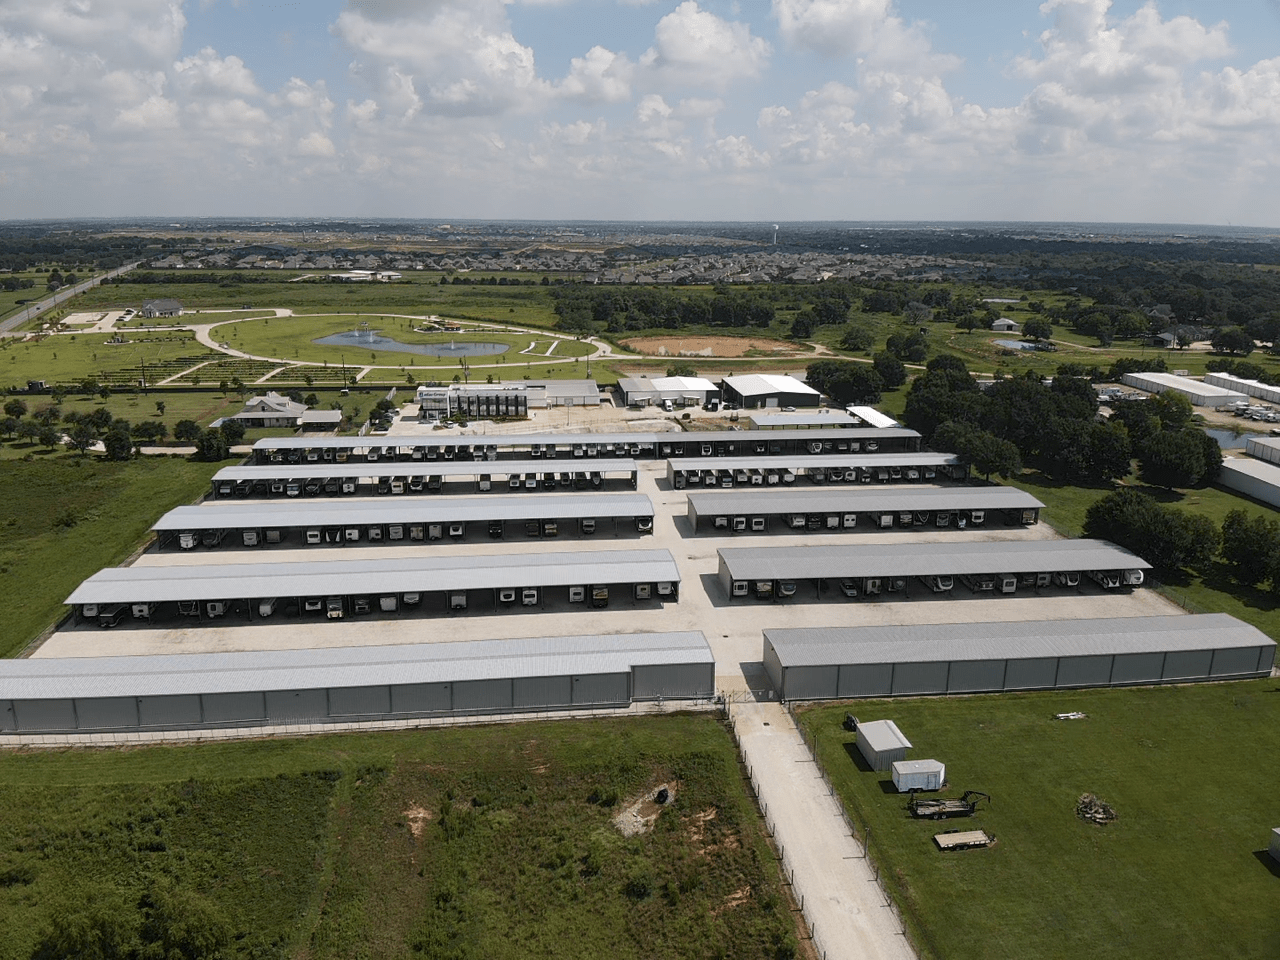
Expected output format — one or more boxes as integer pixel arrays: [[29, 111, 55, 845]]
[[687, 484, 1044, 534]]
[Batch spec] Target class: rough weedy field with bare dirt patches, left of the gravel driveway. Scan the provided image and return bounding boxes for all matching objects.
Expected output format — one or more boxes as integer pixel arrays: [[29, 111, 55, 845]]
[[0, 716, 796, 960]]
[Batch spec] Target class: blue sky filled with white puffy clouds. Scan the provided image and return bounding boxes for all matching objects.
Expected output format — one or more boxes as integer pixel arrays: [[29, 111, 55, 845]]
[[0, 0, 1280, 227]]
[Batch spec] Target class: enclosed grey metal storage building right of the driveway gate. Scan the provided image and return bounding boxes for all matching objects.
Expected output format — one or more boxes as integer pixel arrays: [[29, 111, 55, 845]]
[[764, 613, 1276, 700]]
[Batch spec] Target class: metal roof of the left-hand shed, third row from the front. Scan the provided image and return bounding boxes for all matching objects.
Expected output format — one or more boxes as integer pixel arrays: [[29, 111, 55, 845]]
[[151, 493, 654, 531]]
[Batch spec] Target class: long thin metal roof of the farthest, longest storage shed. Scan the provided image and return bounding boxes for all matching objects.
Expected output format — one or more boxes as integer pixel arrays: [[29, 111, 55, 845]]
[[253, 426, 920, 451]]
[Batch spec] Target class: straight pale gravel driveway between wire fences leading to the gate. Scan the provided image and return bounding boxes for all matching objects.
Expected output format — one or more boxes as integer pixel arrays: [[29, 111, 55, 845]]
[[731, 701, 915, 960]]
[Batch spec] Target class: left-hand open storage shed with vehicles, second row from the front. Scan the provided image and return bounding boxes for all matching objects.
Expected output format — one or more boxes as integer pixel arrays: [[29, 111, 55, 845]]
[[65, 550, 680, 627]]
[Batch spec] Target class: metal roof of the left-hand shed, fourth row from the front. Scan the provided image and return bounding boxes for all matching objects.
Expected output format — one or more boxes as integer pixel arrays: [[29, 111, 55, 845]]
[[214, 457, 639, 484]]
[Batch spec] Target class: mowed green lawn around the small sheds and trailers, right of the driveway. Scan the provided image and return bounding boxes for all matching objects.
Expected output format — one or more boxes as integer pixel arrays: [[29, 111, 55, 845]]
[[800, 680, 1280, 960]]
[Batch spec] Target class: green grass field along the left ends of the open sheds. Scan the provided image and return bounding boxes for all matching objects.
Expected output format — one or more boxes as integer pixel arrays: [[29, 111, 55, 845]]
[[0, 453, 223, 657]]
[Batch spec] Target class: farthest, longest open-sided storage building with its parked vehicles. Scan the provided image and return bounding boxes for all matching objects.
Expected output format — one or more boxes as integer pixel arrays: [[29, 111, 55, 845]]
[[253, 426, 920, 466]]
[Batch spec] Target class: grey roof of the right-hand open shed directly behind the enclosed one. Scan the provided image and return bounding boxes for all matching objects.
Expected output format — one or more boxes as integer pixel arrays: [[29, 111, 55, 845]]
[[718, 540, 1151, 583]]
